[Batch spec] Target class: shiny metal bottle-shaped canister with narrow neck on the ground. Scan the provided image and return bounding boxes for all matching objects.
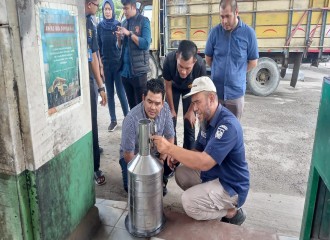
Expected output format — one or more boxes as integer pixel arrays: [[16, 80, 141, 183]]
[[125, 119, 165, 237]]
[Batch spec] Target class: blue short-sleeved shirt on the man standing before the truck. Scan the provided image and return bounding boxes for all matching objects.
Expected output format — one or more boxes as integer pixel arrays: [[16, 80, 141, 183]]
[[205, 19, 259, 100]]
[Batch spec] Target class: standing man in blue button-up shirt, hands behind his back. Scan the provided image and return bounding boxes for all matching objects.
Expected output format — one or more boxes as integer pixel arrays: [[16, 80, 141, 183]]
[[205, 0, 259, 119]]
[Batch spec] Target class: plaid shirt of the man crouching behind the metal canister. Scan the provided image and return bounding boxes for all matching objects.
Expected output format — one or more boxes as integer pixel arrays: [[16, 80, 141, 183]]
[[120, 102, 175, 158]]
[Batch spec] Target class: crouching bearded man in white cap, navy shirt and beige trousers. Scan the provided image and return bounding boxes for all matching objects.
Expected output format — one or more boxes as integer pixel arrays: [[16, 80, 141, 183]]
[[152, 77, 250, 225]]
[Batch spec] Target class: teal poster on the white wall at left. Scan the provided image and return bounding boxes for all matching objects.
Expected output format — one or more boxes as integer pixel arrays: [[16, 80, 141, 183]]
[[39, 8, 81, 114]]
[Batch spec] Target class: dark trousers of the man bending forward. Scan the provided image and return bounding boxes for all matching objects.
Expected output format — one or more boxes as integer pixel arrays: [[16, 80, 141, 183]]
[[172, 87, 195, 150]]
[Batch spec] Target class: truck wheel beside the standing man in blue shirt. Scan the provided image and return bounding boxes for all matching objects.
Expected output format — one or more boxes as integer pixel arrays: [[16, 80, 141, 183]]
[[247, 57, 280, 97]]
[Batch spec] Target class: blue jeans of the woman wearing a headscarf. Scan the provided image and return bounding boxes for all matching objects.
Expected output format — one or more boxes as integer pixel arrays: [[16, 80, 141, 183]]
[[104, 66, 128, 122]]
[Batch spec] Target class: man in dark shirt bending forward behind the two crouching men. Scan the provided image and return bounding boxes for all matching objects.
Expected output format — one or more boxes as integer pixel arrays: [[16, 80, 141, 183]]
[[163, 40, 206, 150]]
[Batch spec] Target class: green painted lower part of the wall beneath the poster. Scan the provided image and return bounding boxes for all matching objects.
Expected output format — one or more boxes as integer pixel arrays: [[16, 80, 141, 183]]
[[0, 132, 95, 240]]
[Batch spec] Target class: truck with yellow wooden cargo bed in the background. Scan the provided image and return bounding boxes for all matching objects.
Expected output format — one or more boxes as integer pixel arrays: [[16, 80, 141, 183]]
[[137, 0, 330, 96]]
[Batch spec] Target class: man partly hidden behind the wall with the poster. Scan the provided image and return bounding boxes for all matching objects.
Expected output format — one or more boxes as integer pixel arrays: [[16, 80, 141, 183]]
[[85, 0, 107, 185]]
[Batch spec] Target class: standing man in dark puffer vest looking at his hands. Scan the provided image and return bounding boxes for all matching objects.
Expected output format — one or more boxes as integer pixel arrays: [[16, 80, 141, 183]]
[[116, 0, 151, 109]]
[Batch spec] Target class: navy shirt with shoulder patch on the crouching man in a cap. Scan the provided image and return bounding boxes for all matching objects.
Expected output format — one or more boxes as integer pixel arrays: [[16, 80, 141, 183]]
[[196, 105, 250, 207]]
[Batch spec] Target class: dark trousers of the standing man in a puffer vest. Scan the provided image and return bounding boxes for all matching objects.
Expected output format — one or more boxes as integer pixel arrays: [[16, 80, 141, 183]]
[[122, 74, 147, 109]]
